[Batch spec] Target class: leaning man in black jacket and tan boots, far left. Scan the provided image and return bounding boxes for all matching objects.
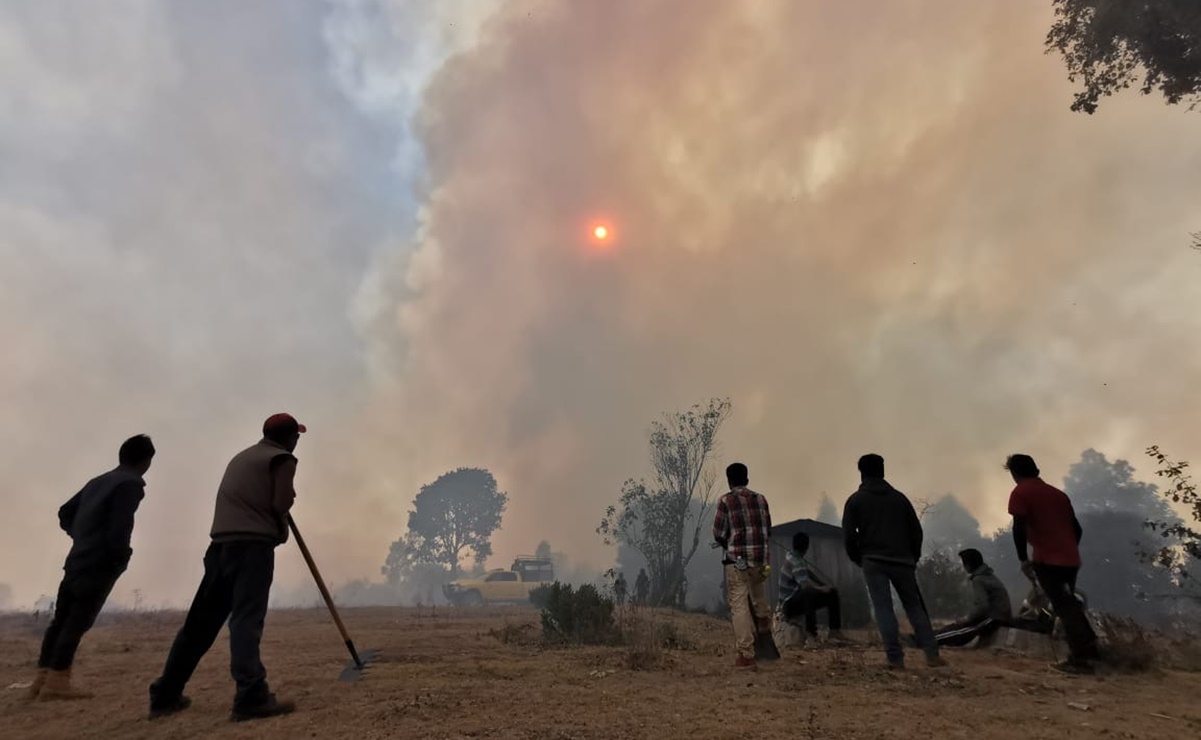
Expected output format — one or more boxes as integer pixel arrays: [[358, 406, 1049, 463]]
[[29, 435, 155, 702]]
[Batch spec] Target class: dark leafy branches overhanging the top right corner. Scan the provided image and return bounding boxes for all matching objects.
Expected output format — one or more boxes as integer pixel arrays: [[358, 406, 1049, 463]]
[[1046, 0, 1201, 114]]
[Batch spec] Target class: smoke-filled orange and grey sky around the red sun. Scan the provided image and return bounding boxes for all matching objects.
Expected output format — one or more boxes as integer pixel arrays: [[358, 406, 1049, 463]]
[[0, 0, 1201, 604]]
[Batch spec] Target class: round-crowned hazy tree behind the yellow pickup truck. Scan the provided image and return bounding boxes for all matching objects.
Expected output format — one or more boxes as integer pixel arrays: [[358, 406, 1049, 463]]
[[384, 467, 508, 578]]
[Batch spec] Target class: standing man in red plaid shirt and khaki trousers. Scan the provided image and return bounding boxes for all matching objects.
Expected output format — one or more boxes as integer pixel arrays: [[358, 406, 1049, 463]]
[[713, 463, 771, 668]]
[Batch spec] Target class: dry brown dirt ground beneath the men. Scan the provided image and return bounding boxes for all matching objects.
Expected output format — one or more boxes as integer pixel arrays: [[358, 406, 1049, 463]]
[[0, 608, 1201, 740]]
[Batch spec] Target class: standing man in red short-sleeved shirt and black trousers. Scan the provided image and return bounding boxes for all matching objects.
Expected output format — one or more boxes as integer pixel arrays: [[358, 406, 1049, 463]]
[[1005, 454, 1097, 673]]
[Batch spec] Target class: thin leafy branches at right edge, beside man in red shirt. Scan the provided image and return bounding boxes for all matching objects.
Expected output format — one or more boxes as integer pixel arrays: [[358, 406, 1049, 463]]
[[1146, 446, 1201, 586]]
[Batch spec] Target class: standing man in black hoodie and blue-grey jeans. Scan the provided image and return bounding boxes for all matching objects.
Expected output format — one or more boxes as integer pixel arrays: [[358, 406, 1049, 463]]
[[842, 454, 946, 670]]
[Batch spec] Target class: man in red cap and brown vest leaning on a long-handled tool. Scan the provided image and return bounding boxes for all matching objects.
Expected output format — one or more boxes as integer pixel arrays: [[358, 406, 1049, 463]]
[[150, 413, 305, 722]]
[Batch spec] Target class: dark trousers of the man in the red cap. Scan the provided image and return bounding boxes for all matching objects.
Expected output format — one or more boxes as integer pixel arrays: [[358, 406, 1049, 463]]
[[150, 542, 275, 708]]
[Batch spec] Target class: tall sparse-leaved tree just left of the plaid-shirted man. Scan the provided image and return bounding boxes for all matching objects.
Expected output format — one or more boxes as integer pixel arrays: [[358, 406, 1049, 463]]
[[597, 399, 730, 604]]
